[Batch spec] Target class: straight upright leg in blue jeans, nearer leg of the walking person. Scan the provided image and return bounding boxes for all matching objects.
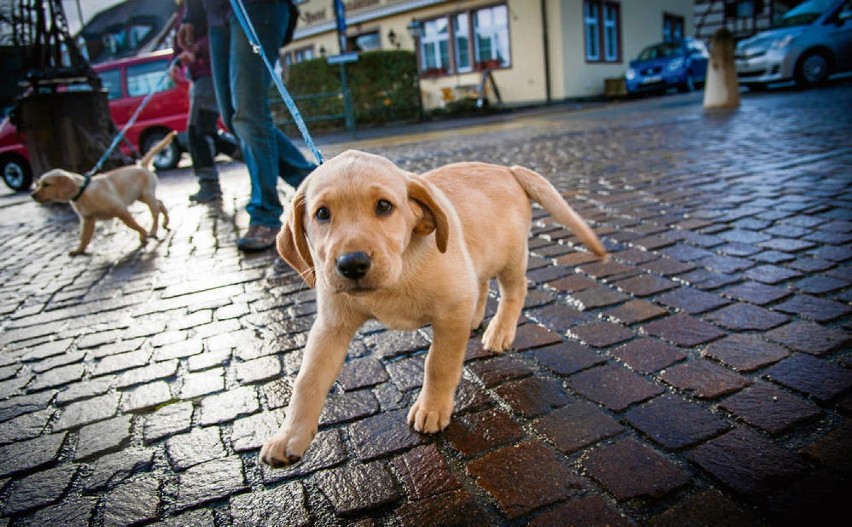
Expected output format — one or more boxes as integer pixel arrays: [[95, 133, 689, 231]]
[[229, 2, 288, 235]]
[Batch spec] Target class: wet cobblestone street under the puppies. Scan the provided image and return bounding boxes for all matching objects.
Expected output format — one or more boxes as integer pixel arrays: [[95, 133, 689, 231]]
[[0, 80, 852, 527]]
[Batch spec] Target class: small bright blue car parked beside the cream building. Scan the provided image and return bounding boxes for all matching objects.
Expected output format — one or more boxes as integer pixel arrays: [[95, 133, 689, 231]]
[[624, 38, 710, 94]]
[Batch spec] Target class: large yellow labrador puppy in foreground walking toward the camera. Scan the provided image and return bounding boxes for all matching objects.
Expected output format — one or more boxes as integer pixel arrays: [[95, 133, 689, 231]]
[[260, 150, 606, 466]]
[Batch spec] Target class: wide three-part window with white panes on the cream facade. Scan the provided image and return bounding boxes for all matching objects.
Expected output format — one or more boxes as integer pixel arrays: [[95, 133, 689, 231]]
[[420, 4, 512, 74]]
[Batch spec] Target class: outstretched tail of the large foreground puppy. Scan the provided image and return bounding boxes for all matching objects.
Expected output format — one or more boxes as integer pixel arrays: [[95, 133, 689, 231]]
[[509, 166, 609, 260]]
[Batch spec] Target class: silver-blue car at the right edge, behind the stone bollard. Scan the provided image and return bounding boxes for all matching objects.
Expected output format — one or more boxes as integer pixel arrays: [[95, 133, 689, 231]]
[[735, 0, 852, 90]]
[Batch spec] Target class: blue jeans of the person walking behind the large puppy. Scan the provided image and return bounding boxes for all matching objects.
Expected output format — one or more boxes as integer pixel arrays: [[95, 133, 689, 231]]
[[208, 0, 315, 229]]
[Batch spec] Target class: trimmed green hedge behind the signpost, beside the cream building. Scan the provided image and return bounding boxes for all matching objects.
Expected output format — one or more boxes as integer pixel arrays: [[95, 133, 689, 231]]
[[273, 50, 420, 133]]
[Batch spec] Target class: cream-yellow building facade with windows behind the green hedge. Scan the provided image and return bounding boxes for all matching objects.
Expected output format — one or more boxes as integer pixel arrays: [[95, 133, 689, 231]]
[[284, 0, 694, 108]]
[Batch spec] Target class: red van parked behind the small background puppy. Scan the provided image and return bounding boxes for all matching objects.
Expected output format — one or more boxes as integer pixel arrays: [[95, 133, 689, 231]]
[[0, 50, 236, 190]]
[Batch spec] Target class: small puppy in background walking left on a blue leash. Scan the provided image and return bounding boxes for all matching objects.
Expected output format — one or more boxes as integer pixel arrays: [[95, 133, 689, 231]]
[[32, 132, 176, 256]]
